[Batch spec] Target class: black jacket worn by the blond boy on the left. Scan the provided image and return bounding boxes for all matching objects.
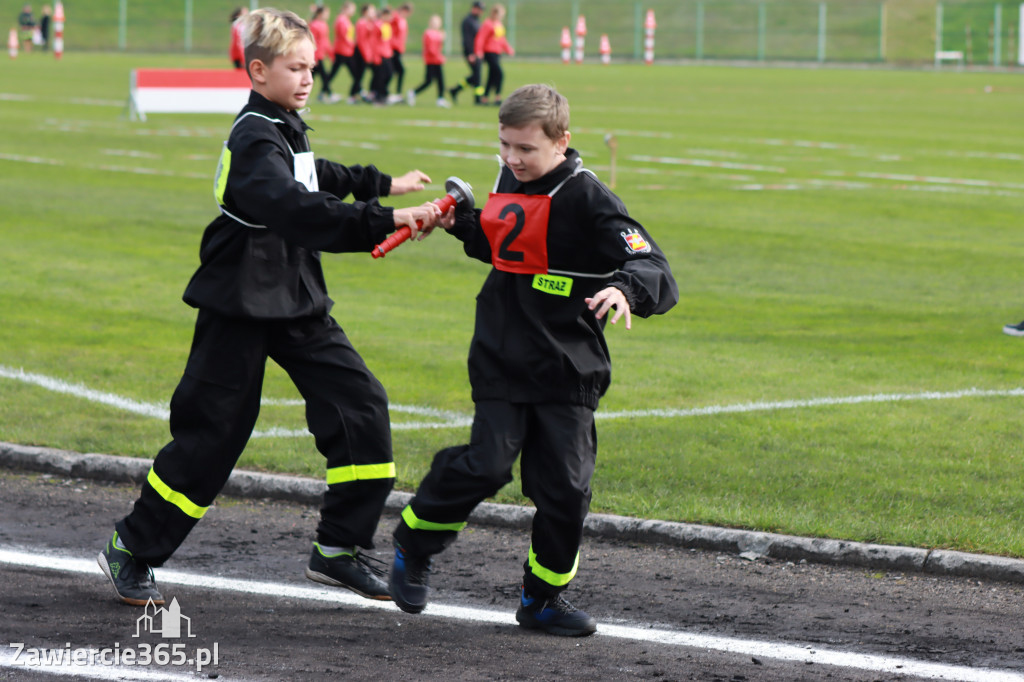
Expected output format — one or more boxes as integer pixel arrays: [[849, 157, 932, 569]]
[[183, 91, 394, 319]]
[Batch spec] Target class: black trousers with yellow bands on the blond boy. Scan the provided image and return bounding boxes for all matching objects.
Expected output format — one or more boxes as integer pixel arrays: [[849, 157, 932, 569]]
[[116, 310, 394, 566]]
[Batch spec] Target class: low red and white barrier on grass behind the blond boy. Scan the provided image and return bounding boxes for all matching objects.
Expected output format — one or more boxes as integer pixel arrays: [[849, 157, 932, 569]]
[[128, 69, 252, 121]]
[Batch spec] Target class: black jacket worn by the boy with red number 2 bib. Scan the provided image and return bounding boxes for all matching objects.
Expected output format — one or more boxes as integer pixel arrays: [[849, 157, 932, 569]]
[[451, 148, 679, 409]]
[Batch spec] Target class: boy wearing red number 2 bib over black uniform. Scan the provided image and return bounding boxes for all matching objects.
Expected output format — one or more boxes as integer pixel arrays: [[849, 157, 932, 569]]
[[389, 85, 679, 636]]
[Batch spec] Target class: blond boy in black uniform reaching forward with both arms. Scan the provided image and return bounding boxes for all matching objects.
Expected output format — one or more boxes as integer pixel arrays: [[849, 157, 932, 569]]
[[97, 9, 440, 605]]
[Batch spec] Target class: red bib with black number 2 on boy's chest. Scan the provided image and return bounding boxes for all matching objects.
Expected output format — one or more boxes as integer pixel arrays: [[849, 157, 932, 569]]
[[480, 194, 551, 274]]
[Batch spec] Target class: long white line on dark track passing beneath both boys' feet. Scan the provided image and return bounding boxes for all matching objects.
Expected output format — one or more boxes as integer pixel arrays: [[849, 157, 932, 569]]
[[0, 548, 1024, 682]]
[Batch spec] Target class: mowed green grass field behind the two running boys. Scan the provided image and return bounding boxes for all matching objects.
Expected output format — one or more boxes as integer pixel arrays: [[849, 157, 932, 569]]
[[0, 53, 1024, 556]]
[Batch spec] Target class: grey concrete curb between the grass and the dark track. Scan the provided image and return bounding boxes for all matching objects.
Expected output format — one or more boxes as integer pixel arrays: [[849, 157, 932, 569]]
[[8, 442, 1024, 583]]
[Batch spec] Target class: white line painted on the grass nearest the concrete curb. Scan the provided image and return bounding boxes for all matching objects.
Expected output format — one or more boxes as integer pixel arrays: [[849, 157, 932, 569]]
[[0, 365, 1024, 438]]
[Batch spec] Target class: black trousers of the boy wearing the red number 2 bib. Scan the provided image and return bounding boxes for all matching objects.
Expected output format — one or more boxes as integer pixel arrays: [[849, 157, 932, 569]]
[[394, 400, 597, 598]]
